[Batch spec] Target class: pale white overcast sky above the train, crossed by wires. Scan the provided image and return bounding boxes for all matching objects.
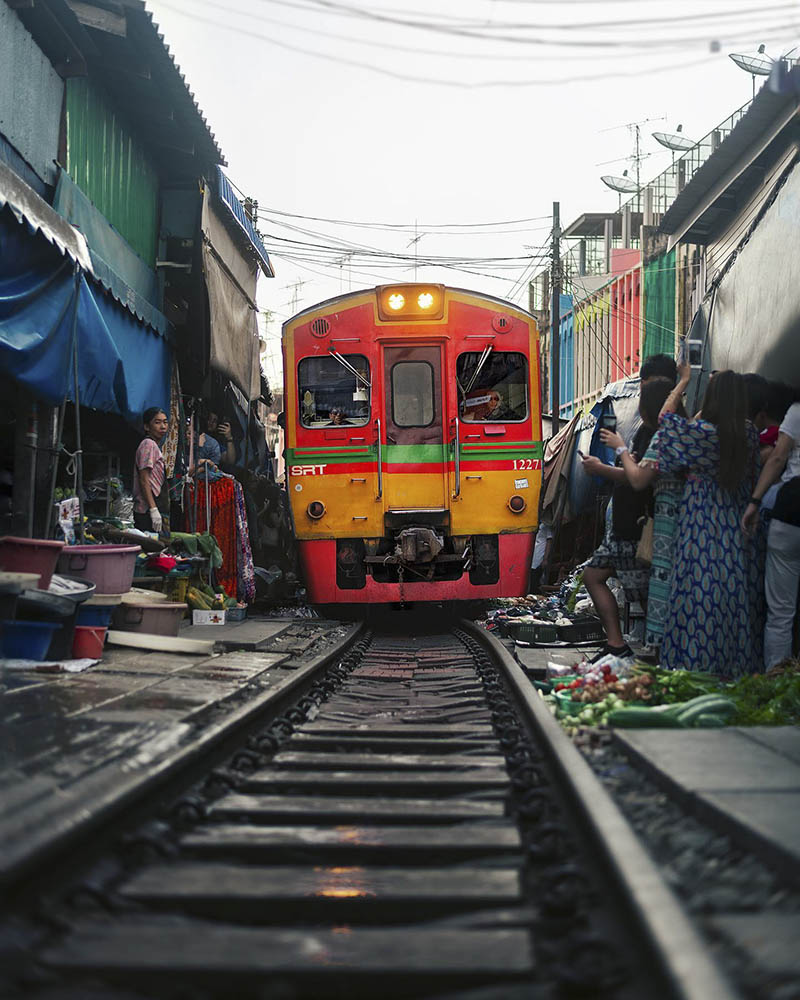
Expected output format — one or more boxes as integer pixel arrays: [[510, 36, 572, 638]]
[[142, 0, 800, 385]]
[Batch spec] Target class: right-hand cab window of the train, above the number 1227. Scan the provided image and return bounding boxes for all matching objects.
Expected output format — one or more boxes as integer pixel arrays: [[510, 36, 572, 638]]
[[456, 349, 528, 423]]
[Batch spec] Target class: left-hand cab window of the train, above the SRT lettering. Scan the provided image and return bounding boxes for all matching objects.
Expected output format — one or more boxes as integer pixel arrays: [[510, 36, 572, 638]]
[[297, 354, 370, 427]]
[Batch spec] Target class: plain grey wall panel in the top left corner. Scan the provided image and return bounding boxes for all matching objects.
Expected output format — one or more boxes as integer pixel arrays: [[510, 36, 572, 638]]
[[0, 3, 64, 184]]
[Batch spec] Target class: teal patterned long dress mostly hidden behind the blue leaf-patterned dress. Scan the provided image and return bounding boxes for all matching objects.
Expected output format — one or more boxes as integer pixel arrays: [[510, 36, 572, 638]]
[[639, 432, 686, 646]]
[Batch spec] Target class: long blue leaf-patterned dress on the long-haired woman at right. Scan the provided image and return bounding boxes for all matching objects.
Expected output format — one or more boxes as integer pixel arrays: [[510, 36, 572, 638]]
[[654, 413, 763, 677]]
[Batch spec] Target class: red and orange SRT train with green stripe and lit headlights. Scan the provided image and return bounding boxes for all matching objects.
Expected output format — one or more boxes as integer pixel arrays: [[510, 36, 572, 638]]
[[283, 284, 542, 604]]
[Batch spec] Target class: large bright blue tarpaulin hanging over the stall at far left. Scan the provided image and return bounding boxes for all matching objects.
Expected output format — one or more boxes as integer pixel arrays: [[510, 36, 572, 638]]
[[0, 192, 172, 425]]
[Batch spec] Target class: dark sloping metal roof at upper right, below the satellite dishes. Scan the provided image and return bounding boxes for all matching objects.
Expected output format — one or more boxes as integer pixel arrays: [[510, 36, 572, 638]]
[[660, 67, 800, 245]]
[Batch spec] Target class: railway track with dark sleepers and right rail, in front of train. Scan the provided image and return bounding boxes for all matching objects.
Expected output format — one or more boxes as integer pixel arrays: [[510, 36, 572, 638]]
[[6, 623, 733, 1000]]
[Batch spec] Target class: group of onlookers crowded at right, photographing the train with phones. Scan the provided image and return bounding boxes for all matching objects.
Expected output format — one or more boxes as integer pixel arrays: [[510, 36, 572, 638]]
[[583, 355, 800, 676]]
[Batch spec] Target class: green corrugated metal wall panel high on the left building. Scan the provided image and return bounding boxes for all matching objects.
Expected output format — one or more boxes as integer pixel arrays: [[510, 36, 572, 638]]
[[67, 77, 158, 267]]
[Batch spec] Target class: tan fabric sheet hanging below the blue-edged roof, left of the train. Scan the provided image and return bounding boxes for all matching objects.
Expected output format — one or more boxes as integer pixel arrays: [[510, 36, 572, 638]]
[[202, 188, 261, 399]]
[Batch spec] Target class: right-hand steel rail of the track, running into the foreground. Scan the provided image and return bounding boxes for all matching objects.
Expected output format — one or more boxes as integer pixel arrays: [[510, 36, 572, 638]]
[[461, 620, 740, 1000]]
